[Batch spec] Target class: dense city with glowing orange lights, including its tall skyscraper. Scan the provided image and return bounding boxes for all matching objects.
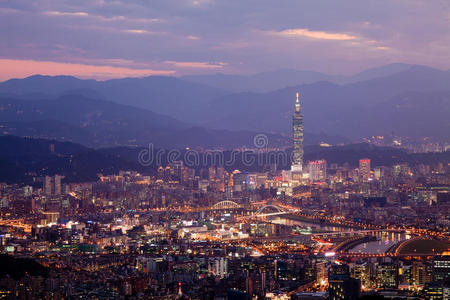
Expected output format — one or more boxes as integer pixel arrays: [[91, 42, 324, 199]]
[[0, 93, 450, 299]]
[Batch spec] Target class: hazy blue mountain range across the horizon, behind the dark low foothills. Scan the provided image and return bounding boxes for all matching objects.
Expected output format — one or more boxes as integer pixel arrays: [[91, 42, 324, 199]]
[[0, 64, 450, 148]]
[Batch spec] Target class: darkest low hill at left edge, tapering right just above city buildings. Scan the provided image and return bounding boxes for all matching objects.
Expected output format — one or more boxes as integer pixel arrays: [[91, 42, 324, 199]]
[[0, 136, 140, 184]]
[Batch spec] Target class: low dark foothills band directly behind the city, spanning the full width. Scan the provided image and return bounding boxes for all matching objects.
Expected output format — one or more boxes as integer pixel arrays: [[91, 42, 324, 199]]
[[0, 136, 450, 185]]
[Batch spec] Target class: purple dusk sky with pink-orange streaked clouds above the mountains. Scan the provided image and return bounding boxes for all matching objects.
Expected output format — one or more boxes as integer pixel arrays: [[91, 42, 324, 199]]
[[0, 0, 450, 80]]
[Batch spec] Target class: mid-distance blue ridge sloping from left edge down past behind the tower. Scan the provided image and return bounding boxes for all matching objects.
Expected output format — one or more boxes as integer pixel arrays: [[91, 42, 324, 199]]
[[0, 95, 348, 149]]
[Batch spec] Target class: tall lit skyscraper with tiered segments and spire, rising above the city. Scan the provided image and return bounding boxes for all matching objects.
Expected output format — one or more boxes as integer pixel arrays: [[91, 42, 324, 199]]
[[291, 93, 303, 172]]
